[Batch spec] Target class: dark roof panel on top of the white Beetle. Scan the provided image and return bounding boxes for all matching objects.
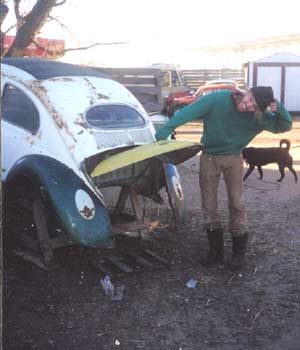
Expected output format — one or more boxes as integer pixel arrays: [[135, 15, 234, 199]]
[[1, 57, 109, 80]]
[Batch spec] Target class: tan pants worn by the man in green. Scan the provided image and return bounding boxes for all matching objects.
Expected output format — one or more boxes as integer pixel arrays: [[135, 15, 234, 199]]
[[199, 152, 247, 237]]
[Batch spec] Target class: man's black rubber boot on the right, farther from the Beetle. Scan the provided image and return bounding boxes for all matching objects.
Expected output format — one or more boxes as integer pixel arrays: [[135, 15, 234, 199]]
[[227, 232, 248, 271]]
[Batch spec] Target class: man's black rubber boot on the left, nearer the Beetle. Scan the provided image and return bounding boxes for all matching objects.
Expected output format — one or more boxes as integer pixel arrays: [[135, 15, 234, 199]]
[[200, 229, 224, 267]]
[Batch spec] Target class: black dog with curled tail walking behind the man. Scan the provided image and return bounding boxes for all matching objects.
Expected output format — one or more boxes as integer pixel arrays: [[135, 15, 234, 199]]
[[243, 139, 298, 182]]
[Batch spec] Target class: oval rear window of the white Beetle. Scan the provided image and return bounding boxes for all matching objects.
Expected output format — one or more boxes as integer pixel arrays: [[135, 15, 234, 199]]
[[86, 105, 145, 129]]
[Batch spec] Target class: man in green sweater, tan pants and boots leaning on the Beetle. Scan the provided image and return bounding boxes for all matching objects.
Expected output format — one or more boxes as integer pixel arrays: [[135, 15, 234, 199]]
[[156, 86, 292, 270]]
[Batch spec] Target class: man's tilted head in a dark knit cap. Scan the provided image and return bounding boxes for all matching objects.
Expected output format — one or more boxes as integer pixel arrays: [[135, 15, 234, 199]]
[[237, 86, 274, 112]]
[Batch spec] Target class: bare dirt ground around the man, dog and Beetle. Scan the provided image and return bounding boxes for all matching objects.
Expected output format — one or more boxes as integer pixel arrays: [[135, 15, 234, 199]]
[[3, 118, 300, 350]]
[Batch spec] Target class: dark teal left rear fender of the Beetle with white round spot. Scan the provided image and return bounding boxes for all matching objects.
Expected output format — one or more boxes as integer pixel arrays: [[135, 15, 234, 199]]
[[4, 155, 112, 247]]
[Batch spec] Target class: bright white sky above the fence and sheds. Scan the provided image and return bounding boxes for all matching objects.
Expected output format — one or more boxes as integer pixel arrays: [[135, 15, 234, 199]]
[[2, 0, 300, 66]]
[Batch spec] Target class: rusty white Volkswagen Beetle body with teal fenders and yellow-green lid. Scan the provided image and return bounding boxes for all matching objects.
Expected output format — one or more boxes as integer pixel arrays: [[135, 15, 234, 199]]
[[1, 58, 200, 266]]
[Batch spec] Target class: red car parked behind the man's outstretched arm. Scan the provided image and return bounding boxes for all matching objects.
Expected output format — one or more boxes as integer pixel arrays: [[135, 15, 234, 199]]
[[169, 81, 238, 117]]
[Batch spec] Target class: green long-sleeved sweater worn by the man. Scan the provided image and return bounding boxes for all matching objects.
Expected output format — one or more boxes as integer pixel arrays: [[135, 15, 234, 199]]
[[155, 90, 292, 155]]
